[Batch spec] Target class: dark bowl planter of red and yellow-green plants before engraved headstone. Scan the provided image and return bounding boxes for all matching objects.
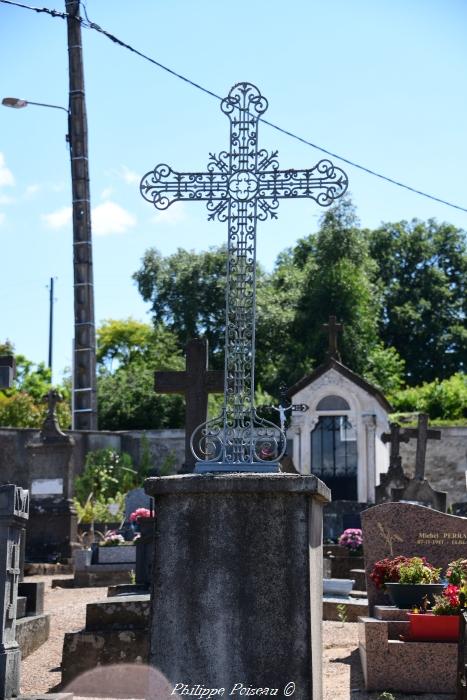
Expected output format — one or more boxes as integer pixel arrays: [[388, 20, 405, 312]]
[[370, 556, 443, 609]]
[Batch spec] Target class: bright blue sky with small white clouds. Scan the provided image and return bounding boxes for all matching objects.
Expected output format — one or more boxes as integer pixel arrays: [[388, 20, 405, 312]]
[[0, 0, 467, 380]]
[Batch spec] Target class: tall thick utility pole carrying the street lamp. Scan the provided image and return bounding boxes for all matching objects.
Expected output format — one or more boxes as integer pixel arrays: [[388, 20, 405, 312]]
[[65, 0, 97, 430]]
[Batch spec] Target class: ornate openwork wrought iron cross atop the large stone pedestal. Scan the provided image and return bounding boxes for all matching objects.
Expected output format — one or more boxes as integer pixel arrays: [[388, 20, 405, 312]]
[[140, 83, 348, 471]]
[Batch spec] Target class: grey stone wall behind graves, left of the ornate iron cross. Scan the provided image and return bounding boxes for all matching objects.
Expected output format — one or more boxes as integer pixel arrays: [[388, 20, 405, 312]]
[[0, 428, 185, 488]]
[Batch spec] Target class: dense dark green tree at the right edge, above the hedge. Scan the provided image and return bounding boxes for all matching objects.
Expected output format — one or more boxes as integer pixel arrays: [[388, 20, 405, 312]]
[[367, 219, 467, 385]]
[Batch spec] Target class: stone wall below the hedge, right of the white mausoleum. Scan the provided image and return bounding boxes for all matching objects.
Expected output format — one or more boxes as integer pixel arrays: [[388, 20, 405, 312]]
[[400, 427, 467, 507]]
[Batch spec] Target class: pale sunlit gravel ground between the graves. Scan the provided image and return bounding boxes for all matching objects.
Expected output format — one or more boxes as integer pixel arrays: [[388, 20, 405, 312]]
[[21, 576, 454, 700]]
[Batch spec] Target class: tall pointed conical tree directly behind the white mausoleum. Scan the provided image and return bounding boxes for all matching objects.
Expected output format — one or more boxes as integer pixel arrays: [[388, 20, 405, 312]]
[[287, 198, 380, 383]]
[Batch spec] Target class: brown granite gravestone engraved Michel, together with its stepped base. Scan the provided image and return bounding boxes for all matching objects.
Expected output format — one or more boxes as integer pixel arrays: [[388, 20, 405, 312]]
[[359, 502, 467, 697]]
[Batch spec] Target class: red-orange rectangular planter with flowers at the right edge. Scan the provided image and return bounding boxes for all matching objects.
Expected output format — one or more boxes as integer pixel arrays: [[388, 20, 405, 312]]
[[408, 583, 465, 642]]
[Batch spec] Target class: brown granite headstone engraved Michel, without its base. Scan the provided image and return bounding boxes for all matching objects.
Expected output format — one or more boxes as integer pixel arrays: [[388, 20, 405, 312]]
[[362, 503, 467, 615]]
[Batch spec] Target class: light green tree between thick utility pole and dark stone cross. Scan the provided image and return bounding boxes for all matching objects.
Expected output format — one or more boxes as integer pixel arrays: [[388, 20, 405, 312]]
[[97, 318, 184, 430]]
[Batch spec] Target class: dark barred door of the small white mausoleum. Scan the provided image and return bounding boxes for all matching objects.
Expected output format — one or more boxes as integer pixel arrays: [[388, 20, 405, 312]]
[[311, 415, 358, 501]]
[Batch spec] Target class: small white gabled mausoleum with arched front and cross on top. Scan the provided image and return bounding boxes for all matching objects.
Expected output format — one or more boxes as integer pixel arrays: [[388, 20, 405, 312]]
[[288, 351, 392, 503]]
